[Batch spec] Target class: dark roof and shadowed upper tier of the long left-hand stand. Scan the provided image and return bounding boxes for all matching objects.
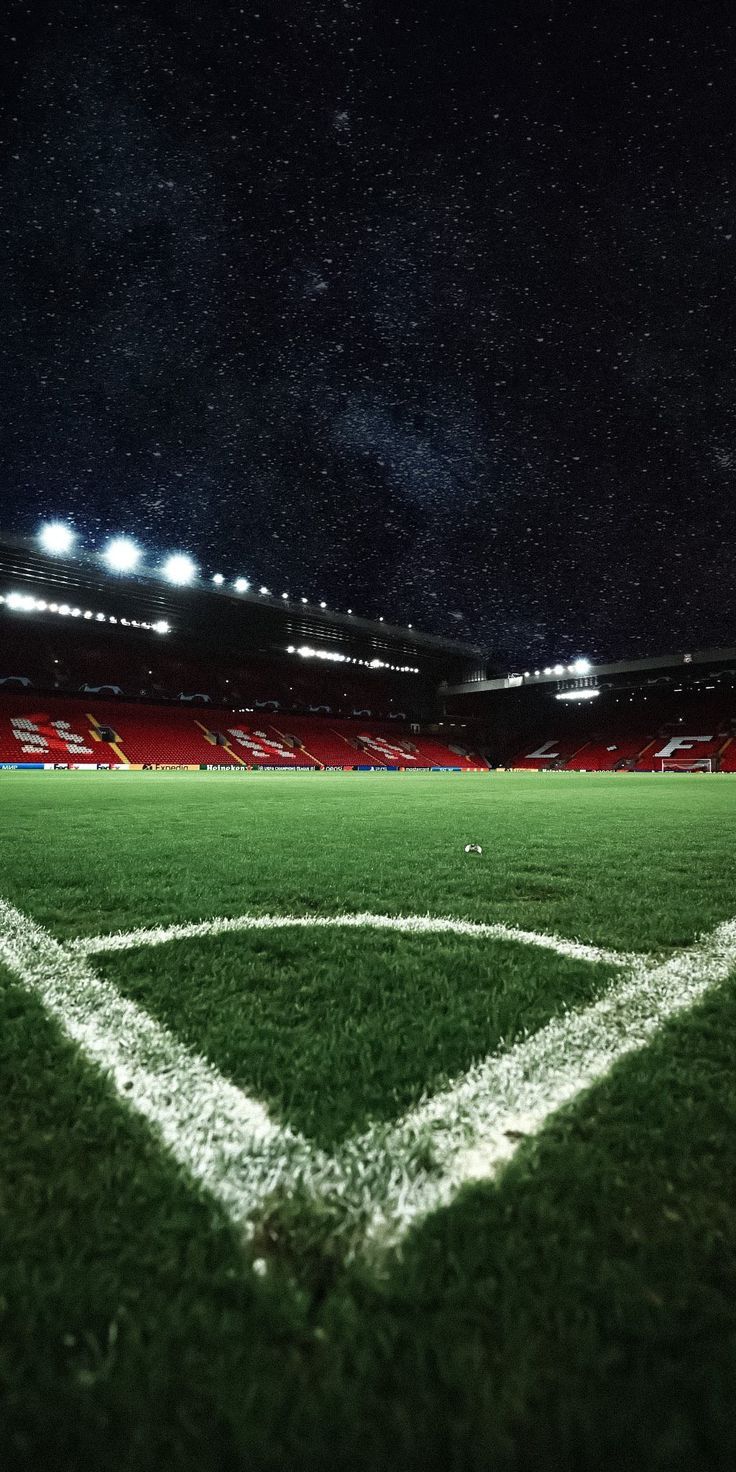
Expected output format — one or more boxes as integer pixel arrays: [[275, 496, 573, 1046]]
[[0, 540, 490, 721]]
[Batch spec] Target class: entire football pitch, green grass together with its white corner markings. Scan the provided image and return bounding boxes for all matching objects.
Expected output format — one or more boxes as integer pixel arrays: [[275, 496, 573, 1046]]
[[0, 771, 736, 1472]]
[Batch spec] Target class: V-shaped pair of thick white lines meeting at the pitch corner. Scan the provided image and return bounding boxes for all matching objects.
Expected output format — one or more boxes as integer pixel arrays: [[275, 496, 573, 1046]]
[[0, 899, 736, 1254]]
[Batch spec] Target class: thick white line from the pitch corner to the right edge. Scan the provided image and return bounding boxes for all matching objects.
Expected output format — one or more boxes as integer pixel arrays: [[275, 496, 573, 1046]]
[[349, 920, 736, 1248]]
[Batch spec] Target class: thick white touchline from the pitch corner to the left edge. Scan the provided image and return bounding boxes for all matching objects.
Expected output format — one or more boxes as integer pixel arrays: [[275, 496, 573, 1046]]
[[0, 899, 328, 1226]]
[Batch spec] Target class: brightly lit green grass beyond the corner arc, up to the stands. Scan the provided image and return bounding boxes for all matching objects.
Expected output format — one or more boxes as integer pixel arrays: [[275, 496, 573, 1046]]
[[0, 773, 736, 949]]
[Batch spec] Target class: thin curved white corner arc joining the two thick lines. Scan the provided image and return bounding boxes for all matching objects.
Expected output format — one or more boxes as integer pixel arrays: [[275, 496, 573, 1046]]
[[68, 913, 637, 967]]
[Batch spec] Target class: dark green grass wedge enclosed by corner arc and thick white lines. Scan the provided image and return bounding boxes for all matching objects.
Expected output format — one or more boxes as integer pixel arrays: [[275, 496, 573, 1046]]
[[97, 930, 611, 1145]]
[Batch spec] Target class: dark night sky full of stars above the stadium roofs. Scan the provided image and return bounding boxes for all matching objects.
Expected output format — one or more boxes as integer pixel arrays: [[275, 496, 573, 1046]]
[[0, 0, 736, 664]]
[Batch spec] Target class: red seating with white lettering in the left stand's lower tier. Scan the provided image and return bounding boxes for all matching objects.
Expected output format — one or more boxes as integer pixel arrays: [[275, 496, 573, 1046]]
[[0, 693, 487, 771]]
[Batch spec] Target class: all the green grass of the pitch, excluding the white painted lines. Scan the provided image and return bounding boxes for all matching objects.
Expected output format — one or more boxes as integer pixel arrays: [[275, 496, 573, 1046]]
[[0, 773, 736, 1472]]
